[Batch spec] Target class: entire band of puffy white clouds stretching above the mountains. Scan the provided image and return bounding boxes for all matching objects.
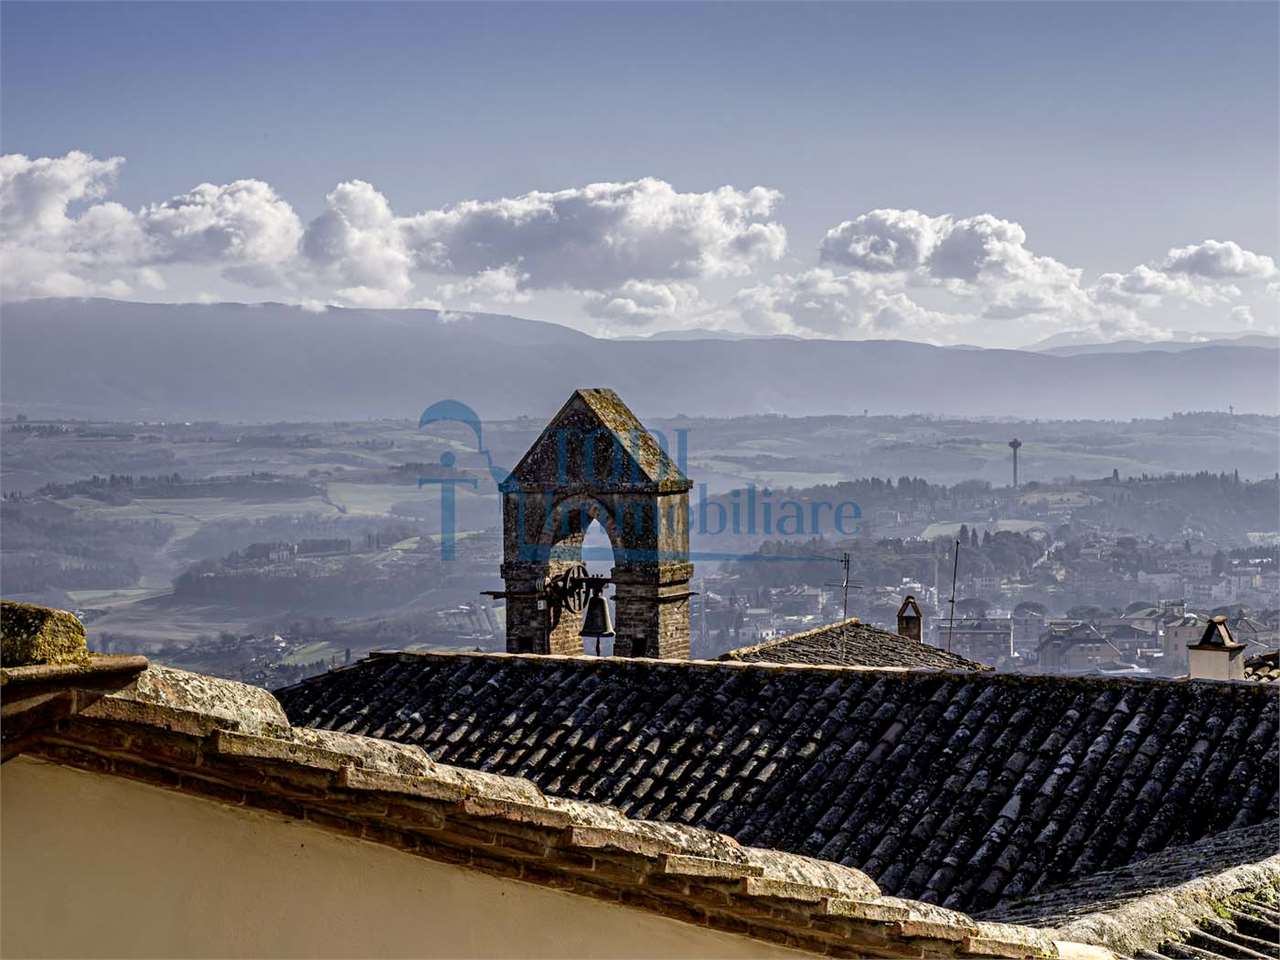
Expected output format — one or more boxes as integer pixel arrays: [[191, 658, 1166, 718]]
[[0, 151, 1280, 342]]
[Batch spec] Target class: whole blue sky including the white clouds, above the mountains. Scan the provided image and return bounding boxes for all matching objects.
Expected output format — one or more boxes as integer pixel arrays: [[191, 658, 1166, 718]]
[[0, 0, 1280, 347]]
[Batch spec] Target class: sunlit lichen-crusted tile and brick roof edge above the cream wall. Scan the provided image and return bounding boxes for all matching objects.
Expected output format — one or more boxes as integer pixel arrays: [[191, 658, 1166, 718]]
[[17, 667, 1111, 960]]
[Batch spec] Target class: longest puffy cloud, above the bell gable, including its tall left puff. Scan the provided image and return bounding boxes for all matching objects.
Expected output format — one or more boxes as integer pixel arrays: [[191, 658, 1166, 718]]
[[302, 178, 786, 303]]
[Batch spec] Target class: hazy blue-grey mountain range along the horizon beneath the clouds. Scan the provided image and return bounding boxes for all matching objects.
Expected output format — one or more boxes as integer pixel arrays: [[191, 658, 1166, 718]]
[[0, 300, 1280, 422]]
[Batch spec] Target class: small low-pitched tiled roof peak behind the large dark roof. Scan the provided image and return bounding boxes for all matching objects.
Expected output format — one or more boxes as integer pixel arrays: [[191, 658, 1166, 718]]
[[721, 617, 991, 669]]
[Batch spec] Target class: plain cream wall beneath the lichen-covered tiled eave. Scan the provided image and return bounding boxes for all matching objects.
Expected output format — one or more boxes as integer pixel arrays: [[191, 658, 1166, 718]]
[[0, 758, 800, 957]]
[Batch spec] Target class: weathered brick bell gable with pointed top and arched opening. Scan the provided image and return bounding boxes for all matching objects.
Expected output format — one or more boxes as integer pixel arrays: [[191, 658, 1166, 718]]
[[500, 389, 692, 658]]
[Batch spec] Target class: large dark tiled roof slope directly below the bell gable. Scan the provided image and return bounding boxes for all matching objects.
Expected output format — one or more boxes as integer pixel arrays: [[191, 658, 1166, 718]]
[[278, 654, 1280, 910]]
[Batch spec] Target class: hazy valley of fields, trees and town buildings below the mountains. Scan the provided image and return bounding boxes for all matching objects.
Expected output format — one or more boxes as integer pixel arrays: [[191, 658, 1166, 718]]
[[0, 413, 1280, 686]]
